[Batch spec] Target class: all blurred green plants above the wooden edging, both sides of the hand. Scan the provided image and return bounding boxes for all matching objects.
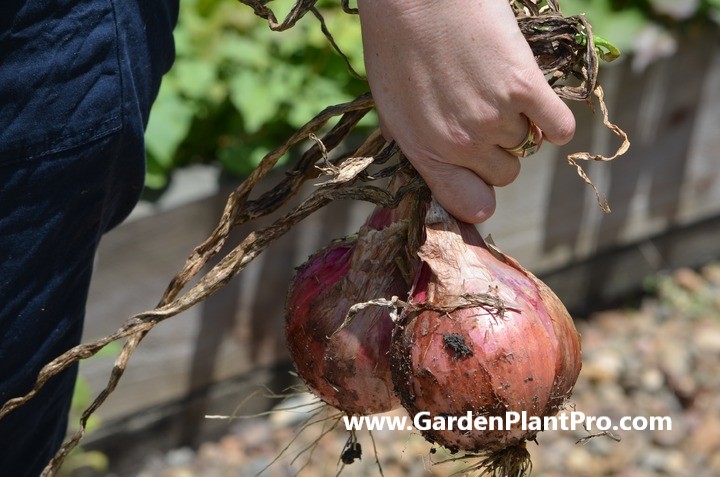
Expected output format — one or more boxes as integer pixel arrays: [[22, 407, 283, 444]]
[[146, 0, 720, 190]]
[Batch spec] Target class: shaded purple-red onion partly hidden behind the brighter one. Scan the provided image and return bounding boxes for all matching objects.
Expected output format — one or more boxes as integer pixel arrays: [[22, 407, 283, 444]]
[[285, 207, 409, 415]]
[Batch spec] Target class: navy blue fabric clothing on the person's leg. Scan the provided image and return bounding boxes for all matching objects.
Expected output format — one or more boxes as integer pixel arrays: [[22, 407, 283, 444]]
[[0, 0, 178, 477]]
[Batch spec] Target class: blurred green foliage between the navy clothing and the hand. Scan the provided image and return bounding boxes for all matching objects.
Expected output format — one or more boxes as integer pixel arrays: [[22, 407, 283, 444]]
[[146, 0, 373, 189]]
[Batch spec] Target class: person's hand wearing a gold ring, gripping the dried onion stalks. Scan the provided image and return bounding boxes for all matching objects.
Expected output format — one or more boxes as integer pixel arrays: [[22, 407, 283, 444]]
[[358, 0, 575, 223]]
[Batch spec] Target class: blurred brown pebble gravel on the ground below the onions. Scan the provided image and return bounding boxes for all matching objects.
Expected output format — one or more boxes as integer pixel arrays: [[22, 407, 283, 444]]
[[138, 263, 720, 477]]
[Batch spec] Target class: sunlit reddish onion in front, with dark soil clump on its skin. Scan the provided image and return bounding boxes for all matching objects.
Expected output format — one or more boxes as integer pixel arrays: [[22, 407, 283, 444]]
[[391, 201, 581, 452]]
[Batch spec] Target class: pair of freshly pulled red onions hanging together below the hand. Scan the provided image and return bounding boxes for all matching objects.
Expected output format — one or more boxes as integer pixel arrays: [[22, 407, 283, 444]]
[[286, 182, 581, 475]]
